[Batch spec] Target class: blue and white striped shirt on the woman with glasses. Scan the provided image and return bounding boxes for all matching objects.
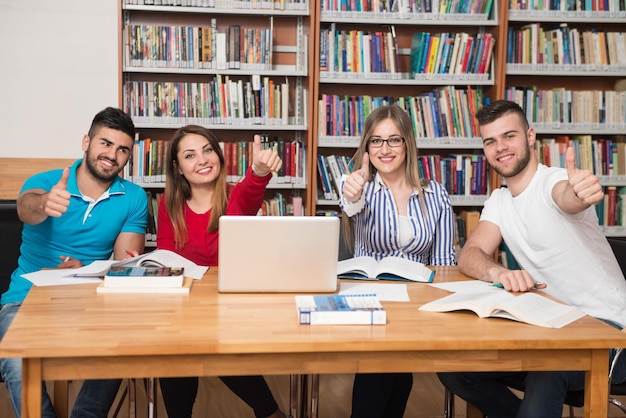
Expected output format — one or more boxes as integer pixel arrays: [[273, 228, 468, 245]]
[[339, 173, 456, 266]]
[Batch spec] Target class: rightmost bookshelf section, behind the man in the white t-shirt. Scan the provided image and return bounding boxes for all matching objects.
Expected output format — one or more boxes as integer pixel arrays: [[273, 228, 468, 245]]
[[505, 0, 626, 237]]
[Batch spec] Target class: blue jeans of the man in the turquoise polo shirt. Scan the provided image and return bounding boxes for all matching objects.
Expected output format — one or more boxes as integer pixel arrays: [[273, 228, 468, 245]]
[[0, 303, 121, 418]]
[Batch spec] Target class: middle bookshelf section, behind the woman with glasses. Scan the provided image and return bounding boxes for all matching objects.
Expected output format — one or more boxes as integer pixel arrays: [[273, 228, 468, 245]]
[[309, 0, 506, 214]]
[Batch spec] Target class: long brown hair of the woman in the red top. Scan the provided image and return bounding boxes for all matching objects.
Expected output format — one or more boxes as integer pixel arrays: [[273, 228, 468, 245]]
[[164, 125, 228, 248]]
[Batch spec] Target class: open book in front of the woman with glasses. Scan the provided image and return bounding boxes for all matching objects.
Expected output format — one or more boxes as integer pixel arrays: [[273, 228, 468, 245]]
[[337, 256, 435, 283]]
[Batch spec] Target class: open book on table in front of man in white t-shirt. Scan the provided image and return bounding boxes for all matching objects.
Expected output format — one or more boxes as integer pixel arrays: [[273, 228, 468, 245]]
[[419, 291, 585, 328]]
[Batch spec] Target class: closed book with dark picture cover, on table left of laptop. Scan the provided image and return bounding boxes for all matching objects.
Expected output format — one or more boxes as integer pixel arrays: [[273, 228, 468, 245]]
[[103, 266, 185, 287]]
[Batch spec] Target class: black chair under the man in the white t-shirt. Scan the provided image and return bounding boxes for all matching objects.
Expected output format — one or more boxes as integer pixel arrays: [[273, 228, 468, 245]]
[[443, 238, 626, 418]]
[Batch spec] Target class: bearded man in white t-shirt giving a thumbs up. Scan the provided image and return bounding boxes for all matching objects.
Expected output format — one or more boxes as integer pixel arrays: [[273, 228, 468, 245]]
[[439, 100, 626, 418]]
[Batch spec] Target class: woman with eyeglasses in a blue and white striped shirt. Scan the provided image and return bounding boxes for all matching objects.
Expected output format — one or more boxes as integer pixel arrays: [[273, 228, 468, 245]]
[[339, 105, 456, 418]]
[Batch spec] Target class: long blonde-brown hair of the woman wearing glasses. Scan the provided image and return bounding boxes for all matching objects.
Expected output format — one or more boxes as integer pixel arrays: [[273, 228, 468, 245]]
[[341, 105, 429, 250]]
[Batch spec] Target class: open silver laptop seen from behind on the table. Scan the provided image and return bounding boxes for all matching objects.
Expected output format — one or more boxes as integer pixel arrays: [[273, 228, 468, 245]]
[[217, 216, 339, 293]]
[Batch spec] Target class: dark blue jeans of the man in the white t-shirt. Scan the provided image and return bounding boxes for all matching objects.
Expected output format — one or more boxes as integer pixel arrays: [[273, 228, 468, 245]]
[[438, 344, 626, 418]]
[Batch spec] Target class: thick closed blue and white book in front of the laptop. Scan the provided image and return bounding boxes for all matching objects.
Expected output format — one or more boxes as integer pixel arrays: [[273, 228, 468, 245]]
[[295, 294, 387, 325]]
